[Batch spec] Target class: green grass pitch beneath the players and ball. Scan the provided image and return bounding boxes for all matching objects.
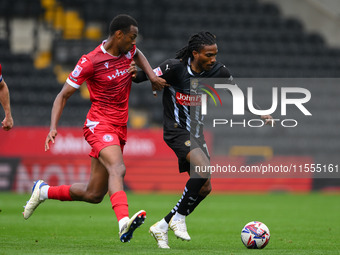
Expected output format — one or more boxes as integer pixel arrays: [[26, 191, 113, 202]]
[[0, 193, 340, 255]]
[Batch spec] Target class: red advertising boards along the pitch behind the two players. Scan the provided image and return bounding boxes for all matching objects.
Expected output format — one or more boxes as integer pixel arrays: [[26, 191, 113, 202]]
[[0, 127, 313, 192]]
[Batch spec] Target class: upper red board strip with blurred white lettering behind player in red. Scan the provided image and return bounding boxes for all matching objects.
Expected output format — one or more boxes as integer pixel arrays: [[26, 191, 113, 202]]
[[0, 127, 171, 157]]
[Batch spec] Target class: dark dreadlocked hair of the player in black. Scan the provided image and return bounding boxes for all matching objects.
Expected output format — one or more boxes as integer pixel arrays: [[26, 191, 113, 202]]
[[176, 32, 216, 62]]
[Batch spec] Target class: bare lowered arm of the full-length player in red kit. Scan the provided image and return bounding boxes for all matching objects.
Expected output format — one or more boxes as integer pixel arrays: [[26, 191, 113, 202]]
[[45, 82, 77, 151]]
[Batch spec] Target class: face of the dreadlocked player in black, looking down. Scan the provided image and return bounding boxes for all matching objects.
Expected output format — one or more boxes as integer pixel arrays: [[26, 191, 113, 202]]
[[194, 44, 218, 71]]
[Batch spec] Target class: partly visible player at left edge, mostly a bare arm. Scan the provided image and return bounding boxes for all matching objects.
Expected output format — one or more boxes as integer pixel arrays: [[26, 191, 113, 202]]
[[0, 64, 13, 131]]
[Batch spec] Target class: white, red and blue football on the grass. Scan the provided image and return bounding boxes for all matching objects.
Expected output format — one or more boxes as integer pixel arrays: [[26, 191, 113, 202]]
[[241, 221, 270, 249]]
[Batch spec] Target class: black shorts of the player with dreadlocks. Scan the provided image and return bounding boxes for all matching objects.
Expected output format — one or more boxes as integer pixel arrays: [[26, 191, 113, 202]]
[[164, 128, 210, 173]]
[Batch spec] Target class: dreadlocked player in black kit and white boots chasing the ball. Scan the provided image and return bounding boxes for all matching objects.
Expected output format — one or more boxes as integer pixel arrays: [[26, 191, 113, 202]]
[[135, 32, 271, 248]]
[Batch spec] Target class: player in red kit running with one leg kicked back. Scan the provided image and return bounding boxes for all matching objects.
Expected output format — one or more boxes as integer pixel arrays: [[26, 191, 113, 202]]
[[24, 15, 167, 242]]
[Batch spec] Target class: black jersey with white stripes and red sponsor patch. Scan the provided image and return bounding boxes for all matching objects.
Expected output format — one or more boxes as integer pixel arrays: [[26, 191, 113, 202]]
[[154, 59, 232, 138]]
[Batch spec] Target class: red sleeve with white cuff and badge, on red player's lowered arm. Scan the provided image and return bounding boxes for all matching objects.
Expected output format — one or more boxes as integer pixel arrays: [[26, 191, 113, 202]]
[[66, 55, 93, 89]]
